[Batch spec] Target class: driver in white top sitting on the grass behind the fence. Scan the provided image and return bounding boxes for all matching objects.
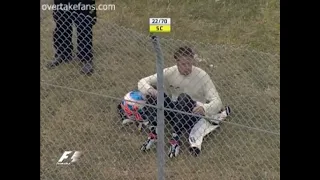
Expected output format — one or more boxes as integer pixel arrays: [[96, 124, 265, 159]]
[[138, 47, 230, 157]]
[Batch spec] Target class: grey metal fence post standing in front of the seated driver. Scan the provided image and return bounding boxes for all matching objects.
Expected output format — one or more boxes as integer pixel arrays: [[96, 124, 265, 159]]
[[151, 36, 165, 180]]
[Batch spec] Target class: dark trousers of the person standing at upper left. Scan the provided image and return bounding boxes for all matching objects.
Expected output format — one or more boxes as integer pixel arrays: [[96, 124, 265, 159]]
[[53, 10, 93, 62]]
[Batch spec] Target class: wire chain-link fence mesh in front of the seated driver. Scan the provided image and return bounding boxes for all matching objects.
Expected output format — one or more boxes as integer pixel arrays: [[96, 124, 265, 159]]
[[40, 9, 280, 180]]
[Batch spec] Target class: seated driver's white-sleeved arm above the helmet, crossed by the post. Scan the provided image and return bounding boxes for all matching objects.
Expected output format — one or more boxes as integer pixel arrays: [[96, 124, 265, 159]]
[[138, 66, 176, 94]]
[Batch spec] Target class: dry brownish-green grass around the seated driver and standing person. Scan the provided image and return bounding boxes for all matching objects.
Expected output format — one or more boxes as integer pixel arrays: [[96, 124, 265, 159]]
[[40, 0, 280, 180]]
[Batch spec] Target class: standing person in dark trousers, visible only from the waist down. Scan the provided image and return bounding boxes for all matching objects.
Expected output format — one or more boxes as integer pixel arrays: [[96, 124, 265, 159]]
[[47, 0, 97, 75]]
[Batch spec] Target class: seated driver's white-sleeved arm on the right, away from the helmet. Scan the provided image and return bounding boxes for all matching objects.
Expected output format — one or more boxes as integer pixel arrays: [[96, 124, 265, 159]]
[[203, 74, 223, 115]]
